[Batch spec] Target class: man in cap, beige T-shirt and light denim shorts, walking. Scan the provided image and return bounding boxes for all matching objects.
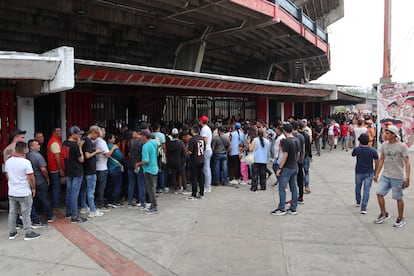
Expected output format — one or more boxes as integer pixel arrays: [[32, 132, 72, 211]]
[[374, 125, 411, 227]]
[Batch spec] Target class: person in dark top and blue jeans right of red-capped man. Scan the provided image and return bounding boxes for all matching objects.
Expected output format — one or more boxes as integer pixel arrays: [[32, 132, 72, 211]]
[[211, 126, 231, 186]]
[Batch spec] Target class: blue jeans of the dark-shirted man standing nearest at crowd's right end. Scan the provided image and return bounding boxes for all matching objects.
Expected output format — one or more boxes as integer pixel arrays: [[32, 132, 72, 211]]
[[278, 168, 298, 210]]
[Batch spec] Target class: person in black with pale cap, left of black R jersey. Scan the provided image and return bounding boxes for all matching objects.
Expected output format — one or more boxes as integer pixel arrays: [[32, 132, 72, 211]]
[[166, 128, 187, 194]]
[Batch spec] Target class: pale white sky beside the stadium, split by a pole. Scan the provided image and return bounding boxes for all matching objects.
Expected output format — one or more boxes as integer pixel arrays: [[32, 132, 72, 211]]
[[313, 0, 414, 87]]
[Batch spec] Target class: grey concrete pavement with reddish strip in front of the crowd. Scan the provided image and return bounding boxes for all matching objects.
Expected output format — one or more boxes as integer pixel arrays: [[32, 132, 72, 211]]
[[0, 150, 414, 276]]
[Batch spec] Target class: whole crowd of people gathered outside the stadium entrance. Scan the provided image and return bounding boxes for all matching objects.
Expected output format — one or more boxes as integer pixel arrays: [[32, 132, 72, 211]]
[[3, 111, 410, 240]]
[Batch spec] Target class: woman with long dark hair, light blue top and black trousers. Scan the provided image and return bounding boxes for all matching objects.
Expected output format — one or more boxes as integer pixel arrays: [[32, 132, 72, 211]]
[[249, 129, 270, 192]]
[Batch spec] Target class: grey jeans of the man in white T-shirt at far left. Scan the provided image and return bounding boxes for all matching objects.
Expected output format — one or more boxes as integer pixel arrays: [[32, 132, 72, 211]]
[[9, 195, 33, 234]]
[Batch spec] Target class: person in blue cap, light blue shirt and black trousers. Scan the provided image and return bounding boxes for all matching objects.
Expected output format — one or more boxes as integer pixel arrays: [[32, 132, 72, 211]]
[[226, 122, 245, 185]]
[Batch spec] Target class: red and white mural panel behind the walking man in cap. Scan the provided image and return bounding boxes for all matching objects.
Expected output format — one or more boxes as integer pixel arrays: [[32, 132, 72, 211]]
[[377, 83, 414, 151]]
